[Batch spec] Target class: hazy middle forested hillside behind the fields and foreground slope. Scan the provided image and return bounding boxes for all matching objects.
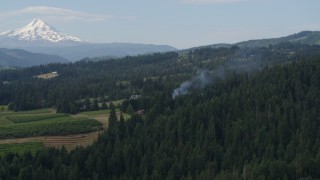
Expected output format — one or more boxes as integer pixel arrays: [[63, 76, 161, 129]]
[[0, 43, 320, 113]]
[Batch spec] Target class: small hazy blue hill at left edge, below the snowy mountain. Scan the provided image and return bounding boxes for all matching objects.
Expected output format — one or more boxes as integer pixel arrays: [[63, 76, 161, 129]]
[[0, 48, 68, 67]]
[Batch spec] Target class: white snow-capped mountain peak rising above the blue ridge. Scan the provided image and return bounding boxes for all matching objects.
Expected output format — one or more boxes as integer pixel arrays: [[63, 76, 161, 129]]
[[0, 18, 82, 43]]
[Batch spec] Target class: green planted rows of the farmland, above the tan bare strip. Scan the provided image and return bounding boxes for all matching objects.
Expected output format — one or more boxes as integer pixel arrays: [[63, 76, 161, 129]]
[[0, 110, 102, 139]]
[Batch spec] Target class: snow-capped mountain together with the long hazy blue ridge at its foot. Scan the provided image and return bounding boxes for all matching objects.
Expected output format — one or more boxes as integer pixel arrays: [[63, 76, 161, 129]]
[[0, 18, 177, 61]]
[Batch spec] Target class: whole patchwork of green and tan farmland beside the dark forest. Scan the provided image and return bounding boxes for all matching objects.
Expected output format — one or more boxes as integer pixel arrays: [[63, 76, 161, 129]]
[[0, 109, 130, 154]]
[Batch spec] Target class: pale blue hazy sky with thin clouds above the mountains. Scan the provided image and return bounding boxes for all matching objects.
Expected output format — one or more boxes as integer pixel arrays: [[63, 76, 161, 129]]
[[0, 0, 320, 49]]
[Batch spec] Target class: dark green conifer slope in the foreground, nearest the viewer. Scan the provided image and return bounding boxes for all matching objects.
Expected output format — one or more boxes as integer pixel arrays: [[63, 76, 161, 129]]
[[0, 47, 320, 179]]
